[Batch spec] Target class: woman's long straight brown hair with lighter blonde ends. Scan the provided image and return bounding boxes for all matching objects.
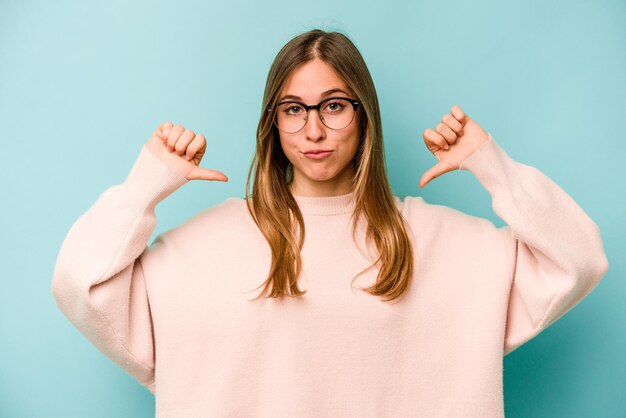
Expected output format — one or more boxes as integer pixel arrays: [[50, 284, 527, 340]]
[[246, 29, 414, 300]]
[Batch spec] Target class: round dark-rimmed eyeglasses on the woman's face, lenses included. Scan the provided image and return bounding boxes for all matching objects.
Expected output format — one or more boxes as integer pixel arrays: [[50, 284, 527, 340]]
[[266, 97, 360, 134]]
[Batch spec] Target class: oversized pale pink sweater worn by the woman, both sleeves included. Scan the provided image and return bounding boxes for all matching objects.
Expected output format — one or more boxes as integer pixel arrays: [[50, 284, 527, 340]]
[[52, 139, 608, 418]]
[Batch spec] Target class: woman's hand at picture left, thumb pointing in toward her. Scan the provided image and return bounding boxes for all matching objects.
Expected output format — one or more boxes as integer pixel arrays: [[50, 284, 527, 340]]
[[146, 122, 228, 182]]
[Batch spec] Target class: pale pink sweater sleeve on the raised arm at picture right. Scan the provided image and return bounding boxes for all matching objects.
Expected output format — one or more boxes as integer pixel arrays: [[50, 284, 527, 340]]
[[460, 136, 608, 355]]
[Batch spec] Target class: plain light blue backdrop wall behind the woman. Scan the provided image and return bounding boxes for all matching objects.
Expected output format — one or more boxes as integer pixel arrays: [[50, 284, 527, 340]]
[[0, 0, 626, 418]]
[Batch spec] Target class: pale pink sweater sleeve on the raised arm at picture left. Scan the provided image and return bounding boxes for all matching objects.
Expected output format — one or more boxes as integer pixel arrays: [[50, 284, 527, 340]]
[[52, 145, 188, 393]]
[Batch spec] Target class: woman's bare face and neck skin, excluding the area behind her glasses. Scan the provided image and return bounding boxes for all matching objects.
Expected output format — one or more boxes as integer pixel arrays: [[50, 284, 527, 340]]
[[278, 58, 361, 196]]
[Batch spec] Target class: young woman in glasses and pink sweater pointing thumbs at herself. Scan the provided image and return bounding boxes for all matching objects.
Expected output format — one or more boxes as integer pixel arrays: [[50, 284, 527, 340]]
[[52, 30, 608, 417]]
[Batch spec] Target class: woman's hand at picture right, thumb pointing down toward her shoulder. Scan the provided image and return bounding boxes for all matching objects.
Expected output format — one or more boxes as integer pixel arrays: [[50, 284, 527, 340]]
[[420, 105, 489, 187]]
